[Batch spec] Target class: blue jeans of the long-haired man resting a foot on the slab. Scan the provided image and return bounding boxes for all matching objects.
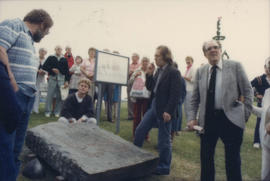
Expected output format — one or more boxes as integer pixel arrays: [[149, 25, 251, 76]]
[[134, 99, 172, 174]]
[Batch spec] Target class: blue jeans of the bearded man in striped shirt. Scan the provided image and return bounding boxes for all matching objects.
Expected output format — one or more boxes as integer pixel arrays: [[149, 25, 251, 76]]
[[13, 89, 35, 176]]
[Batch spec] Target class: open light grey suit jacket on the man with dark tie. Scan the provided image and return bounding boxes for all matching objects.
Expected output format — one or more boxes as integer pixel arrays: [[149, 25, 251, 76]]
[[188, 60, 253, 129]]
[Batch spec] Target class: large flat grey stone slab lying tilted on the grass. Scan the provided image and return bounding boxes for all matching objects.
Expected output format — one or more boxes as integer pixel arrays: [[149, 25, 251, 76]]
[[25, 122, 158, 181]]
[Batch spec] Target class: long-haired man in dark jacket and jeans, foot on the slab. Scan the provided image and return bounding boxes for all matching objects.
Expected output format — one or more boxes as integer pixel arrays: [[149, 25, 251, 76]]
[[134, 46, 181, 175]]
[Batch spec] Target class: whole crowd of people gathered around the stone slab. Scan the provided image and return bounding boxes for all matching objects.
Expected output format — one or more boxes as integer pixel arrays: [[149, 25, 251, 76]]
[[0, 9, 270, 181]]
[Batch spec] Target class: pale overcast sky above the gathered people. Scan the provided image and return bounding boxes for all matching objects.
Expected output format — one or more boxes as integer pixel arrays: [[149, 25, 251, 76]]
[[0, 0, 270, 79]]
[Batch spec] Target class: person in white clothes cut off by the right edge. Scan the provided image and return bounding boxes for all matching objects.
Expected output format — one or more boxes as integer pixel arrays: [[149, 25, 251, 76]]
[[253, 57, 270, 181]]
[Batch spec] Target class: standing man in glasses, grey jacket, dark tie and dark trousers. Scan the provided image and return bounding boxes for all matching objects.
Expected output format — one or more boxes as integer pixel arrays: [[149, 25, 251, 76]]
[[188, 40, 253, 181]]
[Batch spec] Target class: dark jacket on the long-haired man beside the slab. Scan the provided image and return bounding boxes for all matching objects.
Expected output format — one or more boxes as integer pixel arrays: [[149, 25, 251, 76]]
[[146, 64, 181, 120]]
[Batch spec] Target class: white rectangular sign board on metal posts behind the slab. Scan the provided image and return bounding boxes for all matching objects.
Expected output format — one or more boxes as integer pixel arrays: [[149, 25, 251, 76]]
[[95, 51, 129, 85]]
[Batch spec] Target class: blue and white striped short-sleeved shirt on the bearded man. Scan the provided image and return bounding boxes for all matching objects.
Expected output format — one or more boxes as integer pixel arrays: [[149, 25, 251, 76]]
[[0, 18, 39, 96]]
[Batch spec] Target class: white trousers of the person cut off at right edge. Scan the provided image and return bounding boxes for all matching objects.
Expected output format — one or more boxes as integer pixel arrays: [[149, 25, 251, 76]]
[[261, 144, 270, 181]]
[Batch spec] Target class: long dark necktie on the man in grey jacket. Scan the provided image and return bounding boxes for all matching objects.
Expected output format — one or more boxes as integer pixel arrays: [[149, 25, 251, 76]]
[[207, 65, 217, 113]]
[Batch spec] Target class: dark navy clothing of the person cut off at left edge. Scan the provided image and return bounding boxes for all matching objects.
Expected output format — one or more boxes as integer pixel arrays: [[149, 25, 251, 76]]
[[0, 61, 22, 181]]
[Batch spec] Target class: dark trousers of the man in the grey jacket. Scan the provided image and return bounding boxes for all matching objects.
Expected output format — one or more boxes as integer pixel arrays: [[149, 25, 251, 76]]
[[201, 110, 243, 181]]
